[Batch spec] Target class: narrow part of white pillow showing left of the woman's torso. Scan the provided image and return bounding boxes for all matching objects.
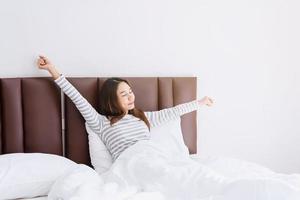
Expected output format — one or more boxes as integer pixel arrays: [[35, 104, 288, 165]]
[[85, 123, 112, 174]]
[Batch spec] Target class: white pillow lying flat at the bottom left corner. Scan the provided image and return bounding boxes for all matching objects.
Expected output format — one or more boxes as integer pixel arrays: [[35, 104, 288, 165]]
[[0, 153, 77, 199]]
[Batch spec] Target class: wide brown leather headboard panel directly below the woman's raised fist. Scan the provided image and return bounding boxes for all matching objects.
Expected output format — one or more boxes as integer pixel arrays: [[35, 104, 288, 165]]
[[22, 78, 62, 155]]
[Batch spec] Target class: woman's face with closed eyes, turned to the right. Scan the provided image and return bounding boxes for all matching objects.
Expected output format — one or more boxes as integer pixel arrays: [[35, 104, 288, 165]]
[[117, 82, 135, 112]]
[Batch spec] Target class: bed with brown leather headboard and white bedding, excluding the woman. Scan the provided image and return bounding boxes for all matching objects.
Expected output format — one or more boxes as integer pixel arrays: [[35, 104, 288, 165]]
[[0, 77, 300, 200]]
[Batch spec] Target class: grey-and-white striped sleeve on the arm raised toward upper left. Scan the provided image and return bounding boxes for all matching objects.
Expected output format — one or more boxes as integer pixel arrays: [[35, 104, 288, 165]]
[[54, 75, 104, 134]]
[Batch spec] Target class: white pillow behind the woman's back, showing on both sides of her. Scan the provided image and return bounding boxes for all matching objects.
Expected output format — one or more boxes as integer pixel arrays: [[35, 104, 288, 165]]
[[85, 117, 189, 174]]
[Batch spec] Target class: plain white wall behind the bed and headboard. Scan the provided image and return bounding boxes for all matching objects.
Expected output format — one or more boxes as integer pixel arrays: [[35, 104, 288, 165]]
[[0, 0, 300, 173]]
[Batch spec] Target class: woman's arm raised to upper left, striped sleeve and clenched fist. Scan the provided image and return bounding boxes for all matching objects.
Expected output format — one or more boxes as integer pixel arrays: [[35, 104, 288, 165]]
[[37, 56, 105, 134]]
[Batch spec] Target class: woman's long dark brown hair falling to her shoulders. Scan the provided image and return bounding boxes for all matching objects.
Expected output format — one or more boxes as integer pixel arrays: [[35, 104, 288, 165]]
[[99, 77, 150, 130]]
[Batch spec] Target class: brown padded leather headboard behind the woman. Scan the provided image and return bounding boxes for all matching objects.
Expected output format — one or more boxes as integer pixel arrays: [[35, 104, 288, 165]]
[[0, 77, 197, 165]]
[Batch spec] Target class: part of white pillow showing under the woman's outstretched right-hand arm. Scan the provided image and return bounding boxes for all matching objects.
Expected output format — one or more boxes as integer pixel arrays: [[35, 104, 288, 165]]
[[150, 117, 189, 156]]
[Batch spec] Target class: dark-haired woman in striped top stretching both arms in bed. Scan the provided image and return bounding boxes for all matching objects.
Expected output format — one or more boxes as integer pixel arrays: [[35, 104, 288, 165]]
[[37, 56, 213, 160]]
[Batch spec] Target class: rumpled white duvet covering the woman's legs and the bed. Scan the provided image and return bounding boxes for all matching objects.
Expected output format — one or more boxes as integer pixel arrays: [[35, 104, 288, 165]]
[[48, 141, 300, 200]]
